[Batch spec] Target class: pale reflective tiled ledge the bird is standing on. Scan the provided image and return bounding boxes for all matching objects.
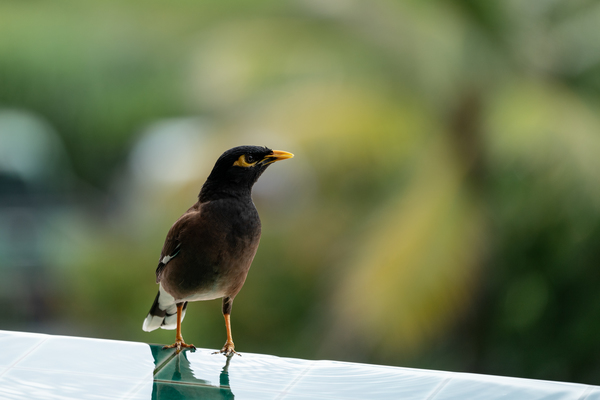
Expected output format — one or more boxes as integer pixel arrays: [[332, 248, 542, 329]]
[[0, 331, 600, 400]]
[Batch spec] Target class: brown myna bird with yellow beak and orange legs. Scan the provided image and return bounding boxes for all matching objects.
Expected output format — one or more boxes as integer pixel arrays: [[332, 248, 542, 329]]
[[142, 146, 294, 357]]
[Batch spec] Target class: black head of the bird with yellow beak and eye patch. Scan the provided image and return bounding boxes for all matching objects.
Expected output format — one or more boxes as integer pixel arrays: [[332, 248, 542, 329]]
[[199, 146, 294, 201]]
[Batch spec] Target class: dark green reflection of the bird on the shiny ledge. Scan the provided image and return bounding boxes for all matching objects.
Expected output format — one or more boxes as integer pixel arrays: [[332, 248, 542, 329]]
[[150, 346, 235, 400]]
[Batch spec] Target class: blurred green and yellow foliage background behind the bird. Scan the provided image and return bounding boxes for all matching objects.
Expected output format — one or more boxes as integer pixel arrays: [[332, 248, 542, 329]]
[[0, 0, 600, 384]]
